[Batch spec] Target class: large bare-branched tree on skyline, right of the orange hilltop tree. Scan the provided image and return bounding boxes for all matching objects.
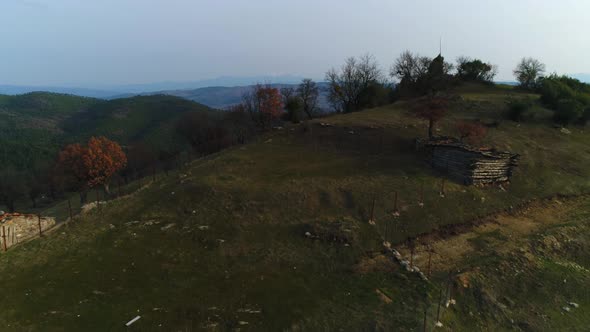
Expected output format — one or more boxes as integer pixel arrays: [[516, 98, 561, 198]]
[[326, 54, 383, 113]]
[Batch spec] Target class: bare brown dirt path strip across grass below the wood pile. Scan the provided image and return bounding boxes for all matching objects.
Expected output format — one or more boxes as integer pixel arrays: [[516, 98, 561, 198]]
[[396, 197, 590, 273]]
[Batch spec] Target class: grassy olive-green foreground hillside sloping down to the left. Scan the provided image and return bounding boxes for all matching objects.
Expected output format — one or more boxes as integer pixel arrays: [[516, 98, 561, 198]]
[[0, 85, 590, 331]]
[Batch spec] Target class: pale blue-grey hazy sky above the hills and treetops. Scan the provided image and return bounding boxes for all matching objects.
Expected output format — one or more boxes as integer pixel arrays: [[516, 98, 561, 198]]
[[0, 0, 590, 86]]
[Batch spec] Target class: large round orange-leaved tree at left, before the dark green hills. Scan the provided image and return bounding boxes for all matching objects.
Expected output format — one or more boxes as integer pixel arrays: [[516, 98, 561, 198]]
[[58, 136, 127, 201]]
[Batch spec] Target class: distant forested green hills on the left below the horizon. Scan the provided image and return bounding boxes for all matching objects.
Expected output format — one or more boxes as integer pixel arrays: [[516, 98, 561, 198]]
[[0, 92, 213, 169]]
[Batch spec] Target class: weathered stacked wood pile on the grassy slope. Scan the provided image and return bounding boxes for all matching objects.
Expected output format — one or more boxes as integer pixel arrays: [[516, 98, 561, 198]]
[[419, 138, 519, 185]]
